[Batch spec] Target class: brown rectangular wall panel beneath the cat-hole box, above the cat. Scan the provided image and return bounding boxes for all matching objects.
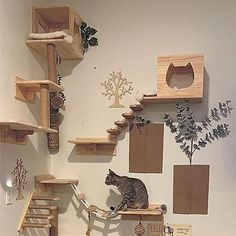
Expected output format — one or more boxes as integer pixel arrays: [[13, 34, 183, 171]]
[[129, 123, 164, 173]]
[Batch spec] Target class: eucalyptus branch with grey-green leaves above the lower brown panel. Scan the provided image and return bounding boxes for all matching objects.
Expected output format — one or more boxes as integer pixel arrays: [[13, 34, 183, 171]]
[[164, 101, 232, 165]]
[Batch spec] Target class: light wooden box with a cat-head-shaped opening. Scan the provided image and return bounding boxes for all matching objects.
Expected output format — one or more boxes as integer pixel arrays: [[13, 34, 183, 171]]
[[157, 54, 204, 102]]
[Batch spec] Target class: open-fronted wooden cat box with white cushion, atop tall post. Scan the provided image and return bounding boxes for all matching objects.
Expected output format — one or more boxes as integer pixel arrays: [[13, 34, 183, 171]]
[[26, 7, 83, 59]]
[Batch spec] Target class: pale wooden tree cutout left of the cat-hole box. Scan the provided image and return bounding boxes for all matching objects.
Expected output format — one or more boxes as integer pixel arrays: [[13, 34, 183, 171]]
[[101, 71, 133, 108]]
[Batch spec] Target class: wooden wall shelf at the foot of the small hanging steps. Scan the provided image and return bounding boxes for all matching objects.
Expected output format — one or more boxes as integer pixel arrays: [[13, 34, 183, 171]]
[[68, 138, 117, 156]]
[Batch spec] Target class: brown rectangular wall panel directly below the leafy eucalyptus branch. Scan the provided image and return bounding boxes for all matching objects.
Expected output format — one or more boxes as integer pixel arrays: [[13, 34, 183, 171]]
[[173, 165, 210, 214]]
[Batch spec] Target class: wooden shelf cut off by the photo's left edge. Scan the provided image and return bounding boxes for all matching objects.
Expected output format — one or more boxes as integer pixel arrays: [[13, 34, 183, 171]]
[[0, 120, 57, 144]]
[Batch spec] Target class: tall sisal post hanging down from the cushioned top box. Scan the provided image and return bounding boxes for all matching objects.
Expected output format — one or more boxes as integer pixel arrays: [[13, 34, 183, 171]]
[[47, 44, 59, 152]]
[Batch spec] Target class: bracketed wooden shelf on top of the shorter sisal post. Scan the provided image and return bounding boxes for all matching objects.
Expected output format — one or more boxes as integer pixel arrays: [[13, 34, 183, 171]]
[[15, 76, 64, 102]]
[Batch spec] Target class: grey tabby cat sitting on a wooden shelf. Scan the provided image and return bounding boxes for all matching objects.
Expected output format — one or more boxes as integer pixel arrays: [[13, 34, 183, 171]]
[[105, 169, 148, 212]]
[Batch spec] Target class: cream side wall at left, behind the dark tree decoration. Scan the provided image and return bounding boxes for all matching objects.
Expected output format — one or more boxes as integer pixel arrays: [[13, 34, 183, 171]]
[[0, 0, 51, 236]]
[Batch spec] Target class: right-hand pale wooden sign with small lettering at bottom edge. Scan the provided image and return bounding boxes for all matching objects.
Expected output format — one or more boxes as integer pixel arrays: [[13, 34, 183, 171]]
[[165, 224, 192, 236]]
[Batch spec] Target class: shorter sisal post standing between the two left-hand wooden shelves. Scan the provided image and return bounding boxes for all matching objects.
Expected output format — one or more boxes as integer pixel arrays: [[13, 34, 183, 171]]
[[40, 84, 49, 128]]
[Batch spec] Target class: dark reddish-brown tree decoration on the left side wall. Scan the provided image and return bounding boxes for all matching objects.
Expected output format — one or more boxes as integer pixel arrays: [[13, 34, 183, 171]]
[[11, 158, 28, 200]]
